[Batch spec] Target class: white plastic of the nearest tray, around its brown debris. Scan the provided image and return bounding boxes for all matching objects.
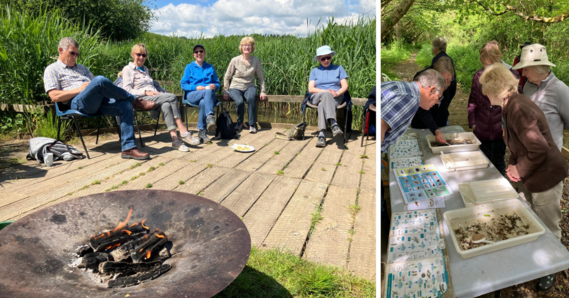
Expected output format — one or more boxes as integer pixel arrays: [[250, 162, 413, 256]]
[[443, 199, 545, 259]]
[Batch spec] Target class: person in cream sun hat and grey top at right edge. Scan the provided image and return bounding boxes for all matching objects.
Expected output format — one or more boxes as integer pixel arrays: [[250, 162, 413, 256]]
[[514, 44, 569, 151]]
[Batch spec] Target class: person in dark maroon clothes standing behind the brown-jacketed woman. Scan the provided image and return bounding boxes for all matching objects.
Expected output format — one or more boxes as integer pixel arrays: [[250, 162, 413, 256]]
[[468, 41, 519, 176]]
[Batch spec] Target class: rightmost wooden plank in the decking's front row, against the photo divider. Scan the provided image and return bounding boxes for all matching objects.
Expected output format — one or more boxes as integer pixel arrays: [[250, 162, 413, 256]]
[[349, 190, 379, 283]]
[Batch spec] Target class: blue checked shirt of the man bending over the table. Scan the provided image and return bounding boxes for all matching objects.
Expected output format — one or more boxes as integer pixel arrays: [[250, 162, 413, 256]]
[[379, 82, 421, 152]]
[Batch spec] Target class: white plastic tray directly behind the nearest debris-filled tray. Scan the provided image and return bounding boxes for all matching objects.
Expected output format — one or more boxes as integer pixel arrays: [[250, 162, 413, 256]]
[[458, 178, 519, 207]]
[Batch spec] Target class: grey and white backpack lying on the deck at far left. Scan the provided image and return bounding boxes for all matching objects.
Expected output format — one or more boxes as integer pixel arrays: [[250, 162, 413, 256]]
[[26, 137, 85, 163]]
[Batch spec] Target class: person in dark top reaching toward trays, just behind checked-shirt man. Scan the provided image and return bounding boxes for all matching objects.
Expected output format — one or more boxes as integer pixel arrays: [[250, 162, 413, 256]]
[[411, 57, 456, 144]]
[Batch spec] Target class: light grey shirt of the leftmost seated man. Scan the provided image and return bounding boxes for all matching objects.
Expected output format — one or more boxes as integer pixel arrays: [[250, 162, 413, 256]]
[[43, 60, 94, 93]]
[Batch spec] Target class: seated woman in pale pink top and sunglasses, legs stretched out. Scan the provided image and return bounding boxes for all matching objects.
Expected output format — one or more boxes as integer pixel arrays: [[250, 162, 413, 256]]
[[122, 43, 199, 152]]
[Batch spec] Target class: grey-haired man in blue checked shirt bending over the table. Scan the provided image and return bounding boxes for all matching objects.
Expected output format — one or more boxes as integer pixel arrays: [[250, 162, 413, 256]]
[[378, 69, 446, 223]]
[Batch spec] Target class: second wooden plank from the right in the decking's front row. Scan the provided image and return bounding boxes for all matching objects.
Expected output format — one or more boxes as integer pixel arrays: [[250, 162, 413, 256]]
[[305, 186, 358, 268]]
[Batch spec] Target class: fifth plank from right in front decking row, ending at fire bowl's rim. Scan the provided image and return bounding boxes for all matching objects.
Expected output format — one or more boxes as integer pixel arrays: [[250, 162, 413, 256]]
[[221, 173, 277, 217]]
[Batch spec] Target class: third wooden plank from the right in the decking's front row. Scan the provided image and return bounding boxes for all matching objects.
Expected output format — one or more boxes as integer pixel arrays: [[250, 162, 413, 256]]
[[263, 181, 328, 256]]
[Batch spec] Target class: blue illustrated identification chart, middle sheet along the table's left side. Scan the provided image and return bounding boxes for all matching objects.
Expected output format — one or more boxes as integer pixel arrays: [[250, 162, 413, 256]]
[[393, 165, 453, 204]]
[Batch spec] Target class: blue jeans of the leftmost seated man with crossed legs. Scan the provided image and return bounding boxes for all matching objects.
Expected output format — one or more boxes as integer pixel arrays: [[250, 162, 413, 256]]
[[71, 76, 136, 151]]
